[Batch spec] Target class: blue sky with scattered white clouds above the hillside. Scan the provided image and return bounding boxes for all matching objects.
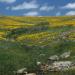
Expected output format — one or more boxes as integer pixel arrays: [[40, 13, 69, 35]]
[[0, 0, 75, 16]]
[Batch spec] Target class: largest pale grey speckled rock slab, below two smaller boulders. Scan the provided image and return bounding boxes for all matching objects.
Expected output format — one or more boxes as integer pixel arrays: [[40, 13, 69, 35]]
[[48, 61, 72, 71]]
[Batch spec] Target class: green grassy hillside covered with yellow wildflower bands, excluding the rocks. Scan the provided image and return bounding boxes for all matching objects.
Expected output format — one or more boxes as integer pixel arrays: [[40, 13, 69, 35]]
[[0, 16, 75, 75]]
